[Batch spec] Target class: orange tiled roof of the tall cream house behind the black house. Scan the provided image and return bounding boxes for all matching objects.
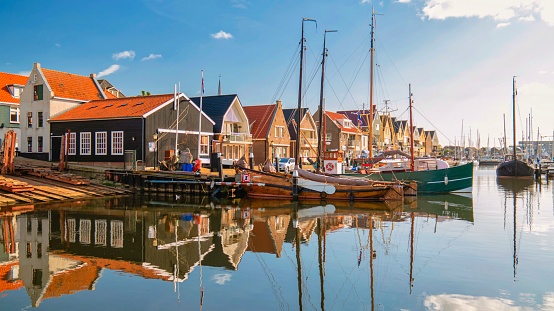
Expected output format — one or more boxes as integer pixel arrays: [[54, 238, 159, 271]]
[[40, 69, 104, 101]]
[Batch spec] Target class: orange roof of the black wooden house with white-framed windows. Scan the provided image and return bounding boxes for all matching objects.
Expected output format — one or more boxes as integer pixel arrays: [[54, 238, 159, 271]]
[[51, 94, 173, 121]]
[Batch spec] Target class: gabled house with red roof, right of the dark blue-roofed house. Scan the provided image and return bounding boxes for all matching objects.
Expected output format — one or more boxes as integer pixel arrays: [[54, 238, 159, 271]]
[[243, 100, 292, 163]]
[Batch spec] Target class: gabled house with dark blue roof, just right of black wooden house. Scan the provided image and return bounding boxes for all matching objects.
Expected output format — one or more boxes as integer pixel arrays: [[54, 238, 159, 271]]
[[191, 94, 252, 165]]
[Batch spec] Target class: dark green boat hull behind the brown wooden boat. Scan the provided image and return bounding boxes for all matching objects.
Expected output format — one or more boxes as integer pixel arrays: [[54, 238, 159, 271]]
[[342, 162, 473, 193]]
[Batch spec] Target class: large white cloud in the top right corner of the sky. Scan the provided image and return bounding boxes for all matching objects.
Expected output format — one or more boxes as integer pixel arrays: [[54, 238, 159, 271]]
[[423, 0, 554, 26]]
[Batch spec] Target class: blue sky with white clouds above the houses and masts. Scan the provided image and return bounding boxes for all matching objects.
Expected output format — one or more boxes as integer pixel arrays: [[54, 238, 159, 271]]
[[0, 0, 554, 146]]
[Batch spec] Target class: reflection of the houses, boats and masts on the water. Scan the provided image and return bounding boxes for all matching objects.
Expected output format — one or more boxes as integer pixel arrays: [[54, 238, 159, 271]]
[[0, 195, 473, 310]]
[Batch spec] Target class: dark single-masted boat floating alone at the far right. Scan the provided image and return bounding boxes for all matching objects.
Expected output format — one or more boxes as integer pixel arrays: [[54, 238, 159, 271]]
[[496, 76, 535, 178]]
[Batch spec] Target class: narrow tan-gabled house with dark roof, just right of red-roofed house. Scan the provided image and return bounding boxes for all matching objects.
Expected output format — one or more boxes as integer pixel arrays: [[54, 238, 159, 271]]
[[283, 108, 318, 159]]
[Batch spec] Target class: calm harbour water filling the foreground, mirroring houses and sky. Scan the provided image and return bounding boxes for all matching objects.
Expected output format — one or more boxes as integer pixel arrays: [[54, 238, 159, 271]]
[[0, 168, 554, 310]]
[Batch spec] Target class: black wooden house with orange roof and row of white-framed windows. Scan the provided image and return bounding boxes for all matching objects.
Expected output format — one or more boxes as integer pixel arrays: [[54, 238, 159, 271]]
[[49, 93, 215, 167]]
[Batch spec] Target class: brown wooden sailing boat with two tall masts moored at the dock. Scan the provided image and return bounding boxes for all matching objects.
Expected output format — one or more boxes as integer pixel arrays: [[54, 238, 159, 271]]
[[237, 18, 404, 201]]
